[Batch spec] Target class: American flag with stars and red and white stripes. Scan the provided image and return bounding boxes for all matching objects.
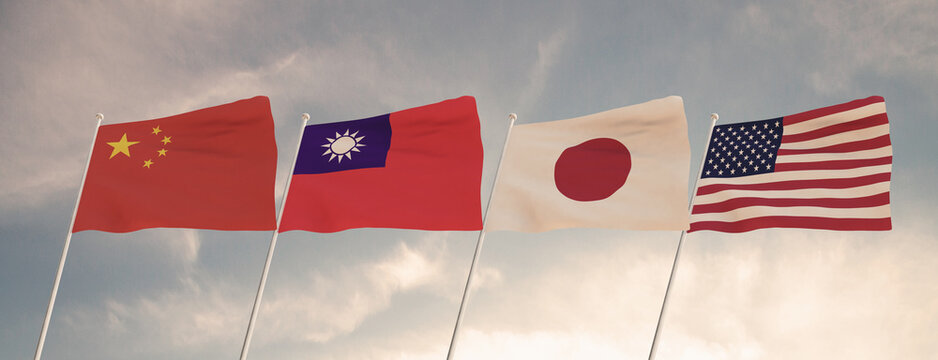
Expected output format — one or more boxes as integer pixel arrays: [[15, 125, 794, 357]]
[[689, 96, 892, 232]]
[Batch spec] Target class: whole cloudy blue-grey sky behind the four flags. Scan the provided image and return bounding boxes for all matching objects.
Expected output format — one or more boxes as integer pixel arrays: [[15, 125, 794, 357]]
[[0, 0, 938, 359]]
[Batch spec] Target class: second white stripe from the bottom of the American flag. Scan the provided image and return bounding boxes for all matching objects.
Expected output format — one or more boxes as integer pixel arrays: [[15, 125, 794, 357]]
[[694, 181, 890, 205]]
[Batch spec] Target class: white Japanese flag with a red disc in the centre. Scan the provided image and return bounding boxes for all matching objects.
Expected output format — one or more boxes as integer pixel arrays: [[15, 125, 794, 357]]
[[484, 96, 690, 232]]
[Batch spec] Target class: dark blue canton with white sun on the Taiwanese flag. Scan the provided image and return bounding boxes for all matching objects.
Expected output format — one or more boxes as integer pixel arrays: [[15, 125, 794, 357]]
[[293, 114, 391, 174]]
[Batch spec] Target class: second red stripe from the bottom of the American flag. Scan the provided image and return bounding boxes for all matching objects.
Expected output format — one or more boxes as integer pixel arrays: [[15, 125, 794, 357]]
[[692, 191, 889, 214]]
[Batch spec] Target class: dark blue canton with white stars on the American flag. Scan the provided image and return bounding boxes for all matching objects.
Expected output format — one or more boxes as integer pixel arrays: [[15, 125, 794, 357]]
[[701, 118, 782, 178]]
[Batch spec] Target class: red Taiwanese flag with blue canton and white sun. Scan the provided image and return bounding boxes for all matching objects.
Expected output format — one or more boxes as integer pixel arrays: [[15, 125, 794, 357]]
[[280, 96, 482, 232]]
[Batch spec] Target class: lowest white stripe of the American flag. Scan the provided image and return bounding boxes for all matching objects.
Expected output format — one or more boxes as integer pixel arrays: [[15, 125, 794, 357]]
[[690, 204, 890, 223]]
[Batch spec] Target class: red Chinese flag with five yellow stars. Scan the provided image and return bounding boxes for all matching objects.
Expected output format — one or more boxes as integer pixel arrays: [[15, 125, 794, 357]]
[[72, 96, 277, 232]]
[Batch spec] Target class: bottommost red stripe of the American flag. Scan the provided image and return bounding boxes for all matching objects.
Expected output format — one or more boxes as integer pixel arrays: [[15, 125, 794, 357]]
[[687, 216, 892, 233]]
